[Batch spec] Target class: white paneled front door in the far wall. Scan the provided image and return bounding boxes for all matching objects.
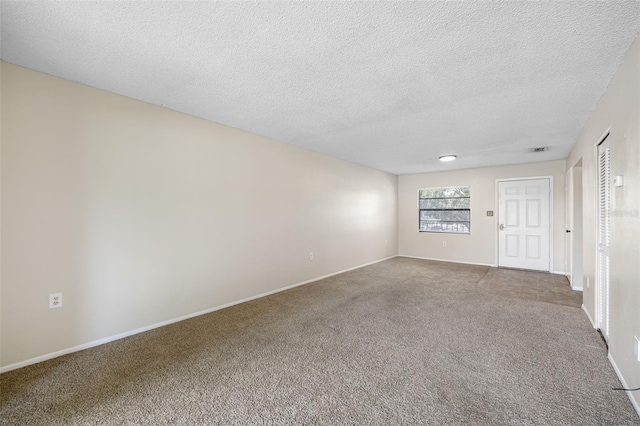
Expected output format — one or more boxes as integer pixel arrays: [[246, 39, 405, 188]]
[[498, 178, 551, 271]]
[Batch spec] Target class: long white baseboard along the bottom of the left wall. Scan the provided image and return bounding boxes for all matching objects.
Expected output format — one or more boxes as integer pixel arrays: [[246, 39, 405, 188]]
[[0, 255, 398, 374]]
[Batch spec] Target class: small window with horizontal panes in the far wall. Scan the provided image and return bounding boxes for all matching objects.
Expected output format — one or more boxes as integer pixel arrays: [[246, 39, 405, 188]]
[[418, 186, 471, 234]]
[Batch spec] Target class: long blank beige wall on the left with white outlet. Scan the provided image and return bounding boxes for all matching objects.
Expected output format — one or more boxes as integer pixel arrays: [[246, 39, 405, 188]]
[[1, 63, 397, 367]]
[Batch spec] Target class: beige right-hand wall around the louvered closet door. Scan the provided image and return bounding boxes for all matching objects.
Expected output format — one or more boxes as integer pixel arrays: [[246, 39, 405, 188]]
[[567, 35, 640, 412]]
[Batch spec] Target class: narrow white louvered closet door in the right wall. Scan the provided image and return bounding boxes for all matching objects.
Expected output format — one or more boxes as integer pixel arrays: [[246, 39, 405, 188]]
[[597, 135, 611, 340]]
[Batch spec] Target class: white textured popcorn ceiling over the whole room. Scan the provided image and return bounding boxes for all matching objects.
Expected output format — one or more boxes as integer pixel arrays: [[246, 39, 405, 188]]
[[1, 1, 640, 174]]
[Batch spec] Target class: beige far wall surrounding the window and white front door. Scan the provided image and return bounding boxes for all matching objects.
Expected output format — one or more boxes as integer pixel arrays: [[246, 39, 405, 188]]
[[398, 161, 565, 272]]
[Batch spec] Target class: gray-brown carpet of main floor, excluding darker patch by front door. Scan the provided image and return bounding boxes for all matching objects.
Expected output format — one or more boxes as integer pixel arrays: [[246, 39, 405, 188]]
[[0, 258, 640, 425]]
